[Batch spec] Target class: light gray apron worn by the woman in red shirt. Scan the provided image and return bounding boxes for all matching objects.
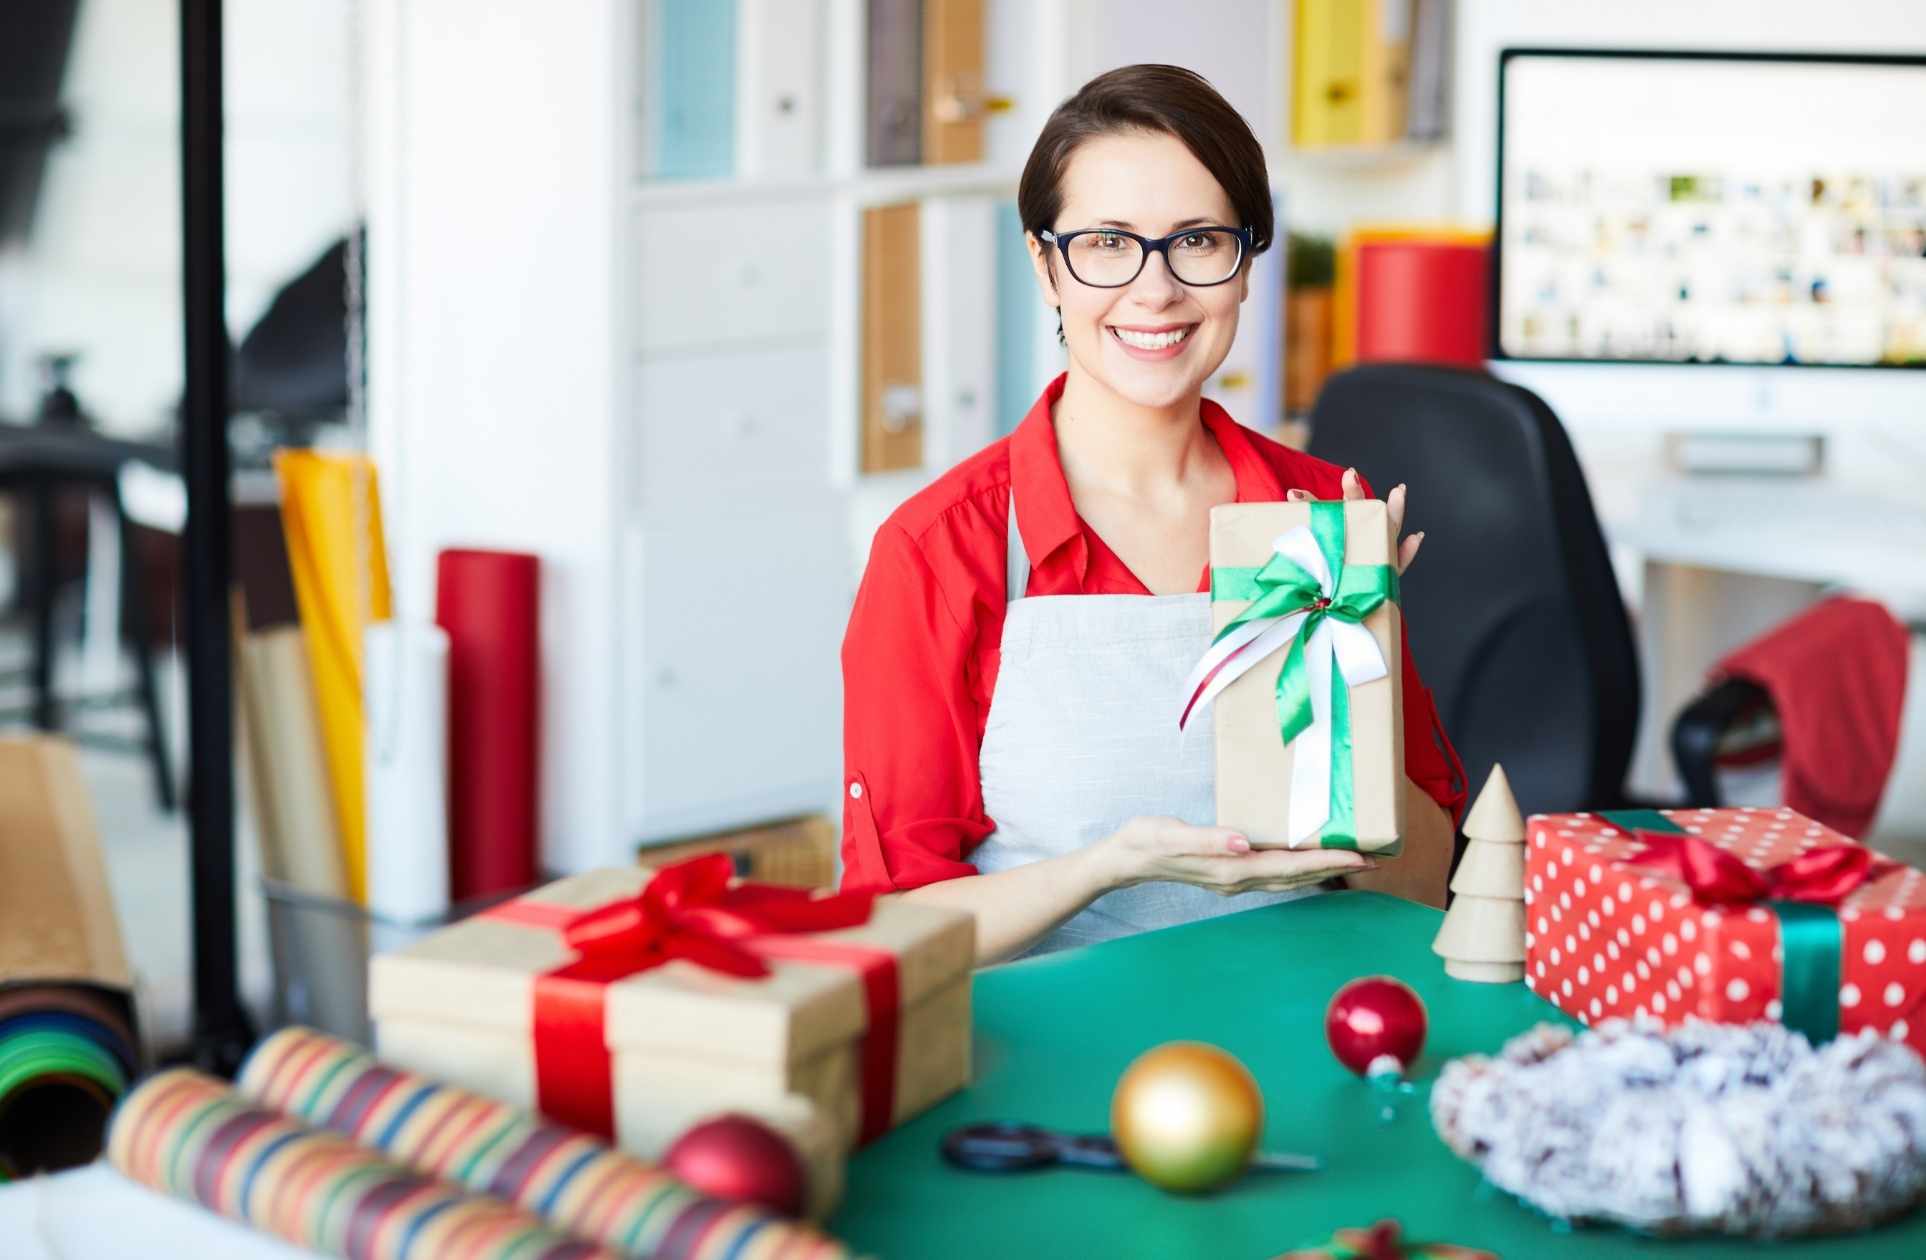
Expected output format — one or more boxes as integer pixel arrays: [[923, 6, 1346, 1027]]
[[969, 493, 1315, 954]]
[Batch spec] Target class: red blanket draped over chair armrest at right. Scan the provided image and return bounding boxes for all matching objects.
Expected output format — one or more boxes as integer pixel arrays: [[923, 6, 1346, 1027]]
[[1714, 597, 1907, 836]]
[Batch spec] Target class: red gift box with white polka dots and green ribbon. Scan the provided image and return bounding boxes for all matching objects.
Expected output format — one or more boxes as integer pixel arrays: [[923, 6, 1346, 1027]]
[[1525, 809, 1926, 1054]]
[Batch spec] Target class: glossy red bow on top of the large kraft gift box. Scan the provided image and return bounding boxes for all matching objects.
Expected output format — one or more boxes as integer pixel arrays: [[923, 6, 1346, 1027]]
[[562, 853, 876, 979]]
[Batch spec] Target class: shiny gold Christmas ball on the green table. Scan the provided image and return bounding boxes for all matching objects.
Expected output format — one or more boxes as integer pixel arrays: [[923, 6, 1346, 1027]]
[[1109, 1040, 1263, 1194]]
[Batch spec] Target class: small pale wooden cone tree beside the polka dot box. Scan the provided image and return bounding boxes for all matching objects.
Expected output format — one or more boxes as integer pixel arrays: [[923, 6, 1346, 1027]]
[[1431, 765, 1525, 984]]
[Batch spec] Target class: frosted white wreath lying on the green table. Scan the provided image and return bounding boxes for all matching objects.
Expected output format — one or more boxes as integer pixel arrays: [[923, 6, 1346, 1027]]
[[1431, 1019, 1926, 1237]]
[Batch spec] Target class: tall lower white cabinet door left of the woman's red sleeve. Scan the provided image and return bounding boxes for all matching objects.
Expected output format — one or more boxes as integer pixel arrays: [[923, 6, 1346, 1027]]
[[620, 491, 851, 840]]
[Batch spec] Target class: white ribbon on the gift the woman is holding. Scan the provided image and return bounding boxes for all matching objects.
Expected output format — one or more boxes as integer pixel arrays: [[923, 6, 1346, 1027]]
[[1179, 526, 1391, 850]]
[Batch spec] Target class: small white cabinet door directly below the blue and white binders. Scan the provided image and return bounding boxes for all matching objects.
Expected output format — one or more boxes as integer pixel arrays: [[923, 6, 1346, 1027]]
[[630, 345, 830, 524]]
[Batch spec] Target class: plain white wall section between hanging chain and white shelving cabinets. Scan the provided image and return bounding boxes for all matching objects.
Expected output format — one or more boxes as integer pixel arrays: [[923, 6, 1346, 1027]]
[[364, 0, 634, 869]]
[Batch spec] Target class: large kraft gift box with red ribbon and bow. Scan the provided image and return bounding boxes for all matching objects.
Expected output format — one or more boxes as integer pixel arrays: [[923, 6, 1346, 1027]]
[[368, 853, 975, 1179]]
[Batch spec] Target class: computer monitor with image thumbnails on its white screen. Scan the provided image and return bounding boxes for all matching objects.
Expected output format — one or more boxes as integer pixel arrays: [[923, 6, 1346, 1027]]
[[1489, 48, 1926, 439]]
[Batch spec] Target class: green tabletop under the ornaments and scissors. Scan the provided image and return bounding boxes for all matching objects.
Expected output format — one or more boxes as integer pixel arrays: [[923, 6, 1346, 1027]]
[[830, 892, 1926, 1260]]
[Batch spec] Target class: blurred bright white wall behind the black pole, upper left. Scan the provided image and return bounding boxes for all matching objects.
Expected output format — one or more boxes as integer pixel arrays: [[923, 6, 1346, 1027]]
[[0, 0, 354, 432]]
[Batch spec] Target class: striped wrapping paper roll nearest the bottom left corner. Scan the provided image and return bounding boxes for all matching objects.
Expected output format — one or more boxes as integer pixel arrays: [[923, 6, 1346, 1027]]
[[108, 1069, 614, 1260]]
